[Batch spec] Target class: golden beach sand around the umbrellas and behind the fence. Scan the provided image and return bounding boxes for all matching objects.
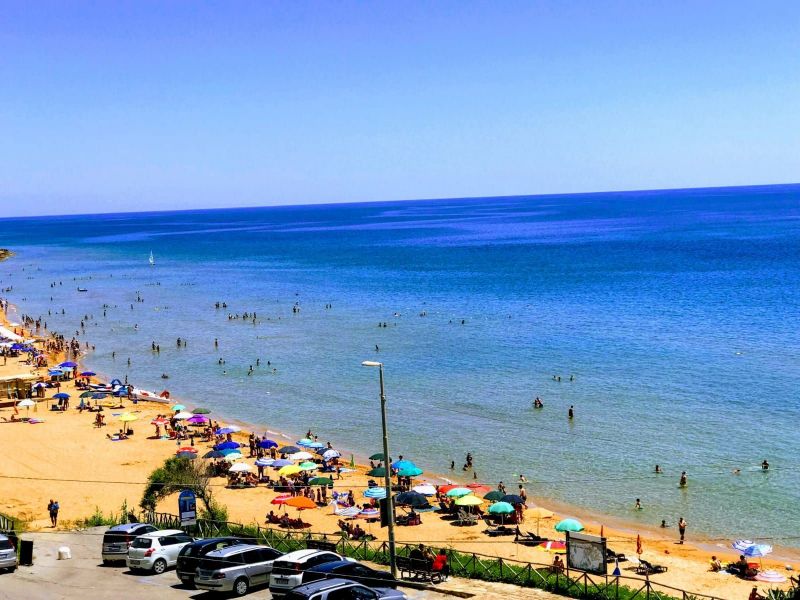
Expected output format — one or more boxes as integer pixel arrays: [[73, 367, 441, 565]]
[[0, 316, 798, 598]]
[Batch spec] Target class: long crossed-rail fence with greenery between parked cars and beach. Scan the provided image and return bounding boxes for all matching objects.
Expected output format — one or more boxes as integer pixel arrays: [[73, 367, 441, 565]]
[[141, 513, 724, 600]]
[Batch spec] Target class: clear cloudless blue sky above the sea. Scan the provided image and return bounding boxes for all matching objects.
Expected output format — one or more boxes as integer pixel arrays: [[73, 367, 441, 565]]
[[0, 0, 800, 216]]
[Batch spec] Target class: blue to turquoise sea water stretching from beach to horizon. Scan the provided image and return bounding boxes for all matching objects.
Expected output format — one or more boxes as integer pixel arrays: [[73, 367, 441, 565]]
[[0, 186, 800, 546]]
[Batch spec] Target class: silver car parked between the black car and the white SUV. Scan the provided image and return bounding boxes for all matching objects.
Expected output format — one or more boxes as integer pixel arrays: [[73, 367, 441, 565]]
[[194, 544, 283, 596]]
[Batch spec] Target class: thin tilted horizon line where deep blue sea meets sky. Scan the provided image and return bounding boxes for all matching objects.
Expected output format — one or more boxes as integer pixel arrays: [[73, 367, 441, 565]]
[[0, 182, 800, 222]]
